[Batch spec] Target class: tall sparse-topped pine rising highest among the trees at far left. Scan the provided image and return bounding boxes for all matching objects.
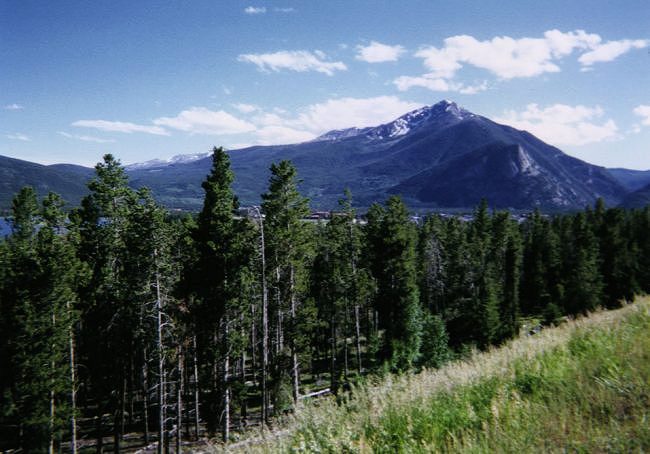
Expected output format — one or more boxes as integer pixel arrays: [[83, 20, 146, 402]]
[[73, 155, 142, 451]]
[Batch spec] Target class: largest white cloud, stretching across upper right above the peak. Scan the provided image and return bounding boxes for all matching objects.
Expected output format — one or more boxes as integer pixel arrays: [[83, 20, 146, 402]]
[[394, 30, 649, 92]]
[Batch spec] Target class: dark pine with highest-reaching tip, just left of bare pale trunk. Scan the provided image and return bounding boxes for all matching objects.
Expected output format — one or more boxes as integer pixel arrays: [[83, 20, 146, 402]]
[[192, 147, 252, 440]]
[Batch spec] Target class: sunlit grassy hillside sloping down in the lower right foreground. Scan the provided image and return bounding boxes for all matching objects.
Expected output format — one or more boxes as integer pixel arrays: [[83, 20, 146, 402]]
[[227, 299, 650, 453]]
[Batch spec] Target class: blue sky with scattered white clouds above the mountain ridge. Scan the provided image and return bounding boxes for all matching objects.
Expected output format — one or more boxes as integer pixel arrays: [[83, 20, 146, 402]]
[[0, 0, 650, 169]]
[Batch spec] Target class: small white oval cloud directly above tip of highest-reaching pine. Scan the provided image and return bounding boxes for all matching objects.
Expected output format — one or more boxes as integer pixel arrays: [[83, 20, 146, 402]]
[[153, 107, 255, 135]]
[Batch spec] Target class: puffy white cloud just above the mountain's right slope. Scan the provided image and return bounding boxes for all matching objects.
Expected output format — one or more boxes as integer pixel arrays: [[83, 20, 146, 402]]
[[494, 104, 620, 146]]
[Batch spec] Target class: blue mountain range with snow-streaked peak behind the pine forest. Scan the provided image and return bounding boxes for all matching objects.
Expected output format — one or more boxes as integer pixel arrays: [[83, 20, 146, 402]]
[[0, 101, 631, 210]]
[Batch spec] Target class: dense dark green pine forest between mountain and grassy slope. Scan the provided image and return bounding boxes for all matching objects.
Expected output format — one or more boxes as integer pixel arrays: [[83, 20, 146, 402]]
[[0, 148, 650, 452]]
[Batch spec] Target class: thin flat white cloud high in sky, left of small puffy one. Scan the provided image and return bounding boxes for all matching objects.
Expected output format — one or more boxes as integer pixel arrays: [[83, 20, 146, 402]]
[[237, 50, 347, 76]]
